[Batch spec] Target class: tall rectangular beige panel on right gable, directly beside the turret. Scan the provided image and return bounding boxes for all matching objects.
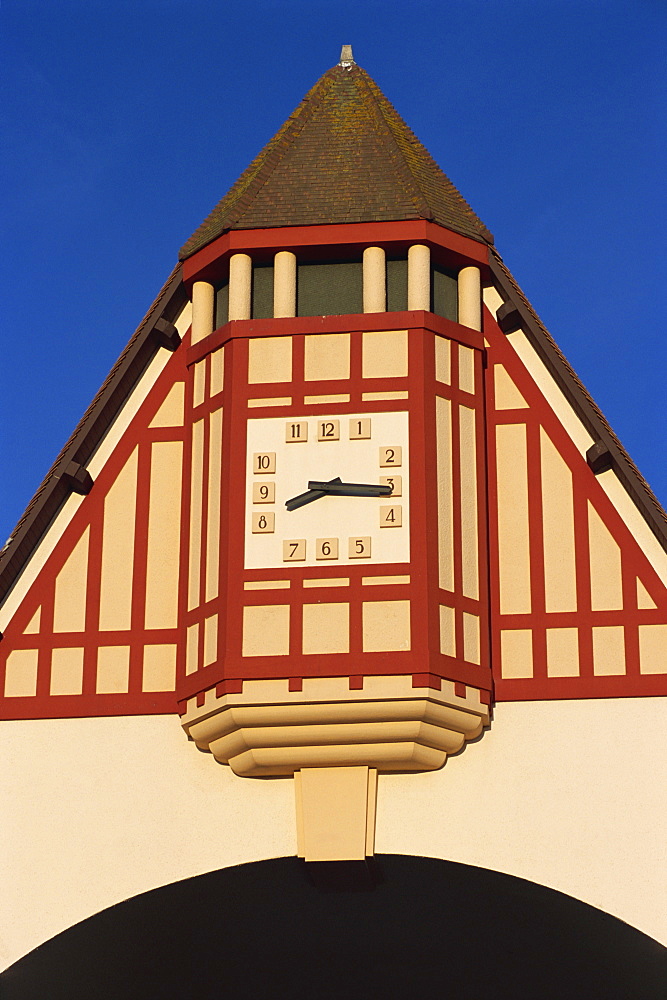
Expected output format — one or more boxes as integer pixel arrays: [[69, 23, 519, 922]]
[[496, 424, 531, 614]]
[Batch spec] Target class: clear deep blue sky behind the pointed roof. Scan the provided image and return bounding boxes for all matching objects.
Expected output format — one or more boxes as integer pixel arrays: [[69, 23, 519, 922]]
[[0, 0, 667, 544]]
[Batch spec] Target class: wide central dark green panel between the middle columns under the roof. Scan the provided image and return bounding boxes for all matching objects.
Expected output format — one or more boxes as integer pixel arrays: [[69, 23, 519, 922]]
[[297, 261, 364, 316]]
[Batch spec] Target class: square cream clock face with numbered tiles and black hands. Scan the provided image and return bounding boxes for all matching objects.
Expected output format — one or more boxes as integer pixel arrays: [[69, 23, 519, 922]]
[[245, 412, 410, 569]]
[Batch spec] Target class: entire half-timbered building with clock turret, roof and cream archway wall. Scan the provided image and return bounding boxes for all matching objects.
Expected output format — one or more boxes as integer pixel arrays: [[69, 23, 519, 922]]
[[0, 46, 667, 936]]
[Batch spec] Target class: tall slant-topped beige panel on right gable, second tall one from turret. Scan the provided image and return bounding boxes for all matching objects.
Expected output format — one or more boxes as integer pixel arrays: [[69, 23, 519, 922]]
[[540, 429, 577, 611]]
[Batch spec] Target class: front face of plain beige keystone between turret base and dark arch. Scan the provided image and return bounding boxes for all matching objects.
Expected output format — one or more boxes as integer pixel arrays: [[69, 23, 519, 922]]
[[299, 767, 368, 861]]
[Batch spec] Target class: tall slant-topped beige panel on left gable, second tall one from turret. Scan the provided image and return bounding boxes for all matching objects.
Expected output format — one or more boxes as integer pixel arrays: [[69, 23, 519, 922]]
[[100, 448, 138, 631]]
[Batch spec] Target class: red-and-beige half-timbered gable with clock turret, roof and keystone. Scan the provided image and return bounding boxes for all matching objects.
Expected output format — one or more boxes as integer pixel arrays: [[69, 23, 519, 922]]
[[0, 45, 667, 984]]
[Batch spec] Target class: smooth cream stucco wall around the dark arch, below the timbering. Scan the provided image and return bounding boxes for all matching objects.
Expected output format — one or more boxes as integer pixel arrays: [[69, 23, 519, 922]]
[[0, 698, 667, 967]]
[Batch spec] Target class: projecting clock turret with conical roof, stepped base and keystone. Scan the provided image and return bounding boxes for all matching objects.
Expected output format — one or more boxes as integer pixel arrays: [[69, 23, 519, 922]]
[[177, 47, 492, 860]]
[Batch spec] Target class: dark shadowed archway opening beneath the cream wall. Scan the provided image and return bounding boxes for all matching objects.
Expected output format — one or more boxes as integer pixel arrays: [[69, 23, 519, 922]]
[[0, 855, 667, 1000]]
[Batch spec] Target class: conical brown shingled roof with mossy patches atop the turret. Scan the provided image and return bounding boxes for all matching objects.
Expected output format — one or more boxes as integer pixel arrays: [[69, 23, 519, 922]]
[[181, 63, 493, 258]]
